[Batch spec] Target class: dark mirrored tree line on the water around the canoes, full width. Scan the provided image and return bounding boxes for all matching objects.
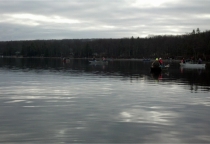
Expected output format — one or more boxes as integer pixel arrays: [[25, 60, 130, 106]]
[[0, 58, 210, 90]]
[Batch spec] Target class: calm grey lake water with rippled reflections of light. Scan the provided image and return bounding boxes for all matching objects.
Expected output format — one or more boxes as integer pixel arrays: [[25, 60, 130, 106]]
[[0, 58, 210, 143]]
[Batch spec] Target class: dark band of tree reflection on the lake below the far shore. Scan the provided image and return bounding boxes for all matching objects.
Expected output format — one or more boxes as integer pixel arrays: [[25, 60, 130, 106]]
[[0, 58, 210, 92]]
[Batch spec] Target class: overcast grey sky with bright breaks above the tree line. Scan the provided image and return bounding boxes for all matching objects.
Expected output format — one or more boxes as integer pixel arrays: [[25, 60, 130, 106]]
[[0, 0, 210, 41]]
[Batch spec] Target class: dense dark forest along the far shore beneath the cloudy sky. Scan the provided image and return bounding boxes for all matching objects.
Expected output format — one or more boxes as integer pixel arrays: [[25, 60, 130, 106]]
[[0, 28, 210, 60]]
